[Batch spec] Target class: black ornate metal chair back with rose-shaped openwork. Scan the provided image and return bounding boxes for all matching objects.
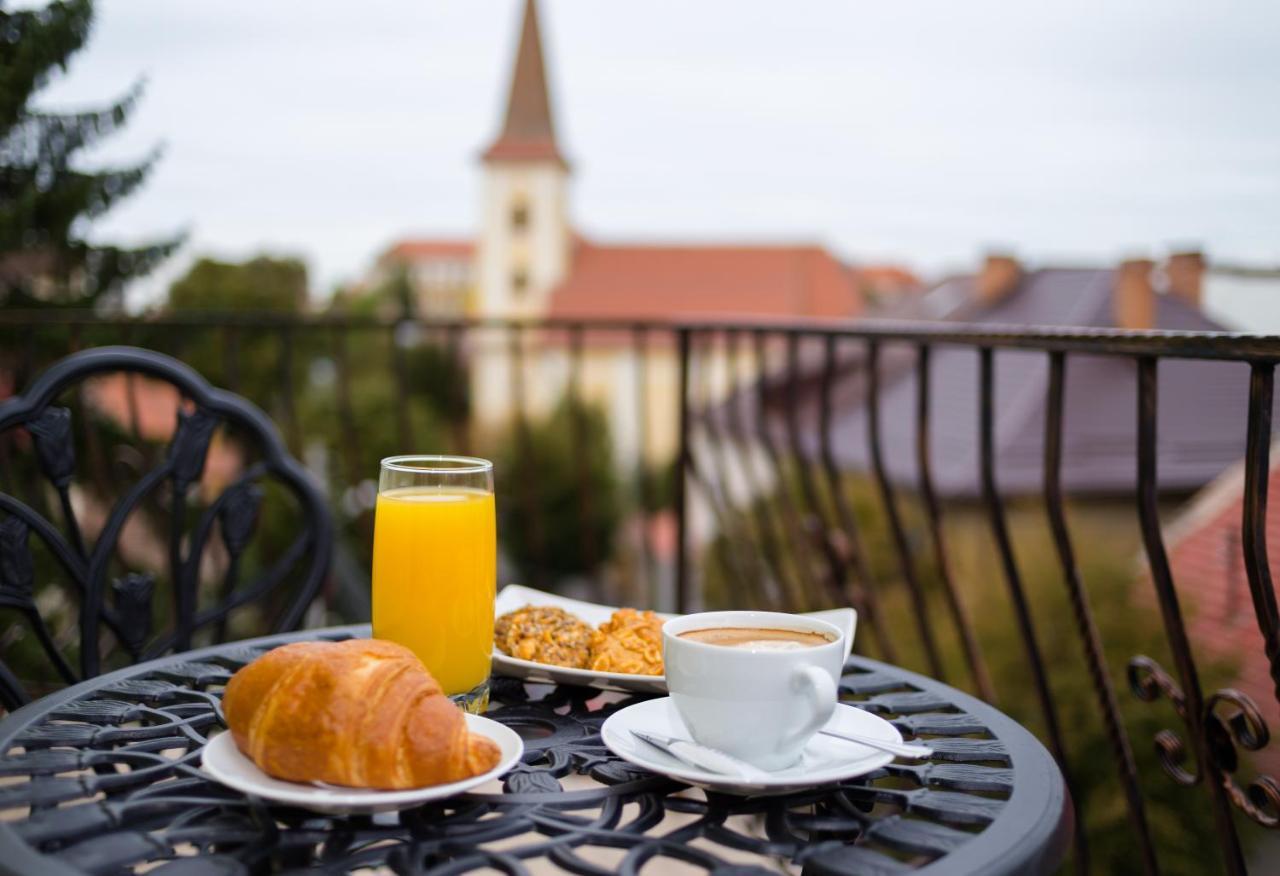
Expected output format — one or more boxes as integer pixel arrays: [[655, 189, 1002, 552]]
[[0, 347, 333, 710]]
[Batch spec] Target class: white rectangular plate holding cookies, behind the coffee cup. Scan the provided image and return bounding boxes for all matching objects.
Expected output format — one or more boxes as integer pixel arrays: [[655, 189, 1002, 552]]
[[493, 584, 858, 693]]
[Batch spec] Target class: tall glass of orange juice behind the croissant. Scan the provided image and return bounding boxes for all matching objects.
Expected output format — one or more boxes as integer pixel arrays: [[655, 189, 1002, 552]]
[[374, 456, 498, 712]]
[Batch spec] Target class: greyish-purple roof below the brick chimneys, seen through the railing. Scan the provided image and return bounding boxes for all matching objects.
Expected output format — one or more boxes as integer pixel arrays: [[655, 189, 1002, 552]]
[[783, 269, 1264, 497]]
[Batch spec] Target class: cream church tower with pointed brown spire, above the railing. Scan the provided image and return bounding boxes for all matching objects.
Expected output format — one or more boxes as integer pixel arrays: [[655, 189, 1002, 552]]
[[476, 0, 572, 318]]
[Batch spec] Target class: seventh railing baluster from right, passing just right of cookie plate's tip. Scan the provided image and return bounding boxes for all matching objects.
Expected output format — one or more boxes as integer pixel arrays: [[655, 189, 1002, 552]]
[[818, 334, 897, 663]]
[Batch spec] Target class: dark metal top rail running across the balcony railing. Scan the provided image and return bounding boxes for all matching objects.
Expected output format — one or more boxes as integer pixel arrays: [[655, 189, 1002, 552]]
[[0, 309, 1280, 362]]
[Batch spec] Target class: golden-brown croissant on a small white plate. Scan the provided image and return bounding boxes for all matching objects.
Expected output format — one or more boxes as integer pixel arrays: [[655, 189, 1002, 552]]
[[223, 639, 499, 790]]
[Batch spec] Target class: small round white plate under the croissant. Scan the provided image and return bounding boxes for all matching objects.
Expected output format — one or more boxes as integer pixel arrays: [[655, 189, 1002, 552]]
[[201, 713, 525, 815]]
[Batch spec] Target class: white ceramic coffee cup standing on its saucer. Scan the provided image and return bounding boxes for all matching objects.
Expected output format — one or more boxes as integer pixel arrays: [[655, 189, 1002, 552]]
[[662, 611, 845, 770]]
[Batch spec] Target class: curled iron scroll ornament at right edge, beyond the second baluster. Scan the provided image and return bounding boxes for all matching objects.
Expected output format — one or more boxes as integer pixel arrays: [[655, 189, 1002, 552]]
[[1204, 688, 1280, 827]]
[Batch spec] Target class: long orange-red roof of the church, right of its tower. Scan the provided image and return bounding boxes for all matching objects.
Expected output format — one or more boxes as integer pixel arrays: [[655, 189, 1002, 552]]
[[550, 243, 863, 319]]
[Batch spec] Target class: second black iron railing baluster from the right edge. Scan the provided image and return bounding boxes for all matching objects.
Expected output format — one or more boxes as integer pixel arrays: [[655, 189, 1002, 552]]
[[1138, 356, 1245, 873]]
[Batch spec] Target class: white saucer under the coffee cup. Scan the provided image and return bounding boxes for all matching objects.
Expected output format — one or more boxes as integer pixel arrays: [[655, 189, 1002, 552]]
[[600, 697, 902, 795]]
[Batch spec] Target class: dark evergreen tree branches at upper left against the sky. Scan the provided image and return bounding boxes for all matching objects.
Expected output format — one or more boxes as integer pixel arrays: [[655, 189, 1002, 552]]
[[0, 0, 178, 307]]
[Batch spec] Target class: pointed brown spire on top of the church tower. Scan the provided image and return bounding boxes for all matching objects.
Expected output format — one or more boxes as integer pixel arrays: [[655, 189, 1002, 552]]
[[484, 0, 564, 164]]
